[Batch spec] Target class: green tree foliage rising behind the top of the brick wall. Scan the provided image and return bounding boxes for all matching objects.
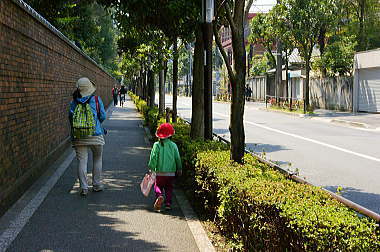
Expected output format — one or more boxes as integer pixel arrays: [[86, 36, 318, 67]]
[[26, 0, 118, 76]]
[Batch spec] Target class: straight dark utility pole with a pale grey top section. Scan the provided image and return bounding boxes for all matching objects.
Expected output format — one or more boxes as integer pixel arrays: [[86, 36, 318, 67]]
[[202, 0, 214, 140]]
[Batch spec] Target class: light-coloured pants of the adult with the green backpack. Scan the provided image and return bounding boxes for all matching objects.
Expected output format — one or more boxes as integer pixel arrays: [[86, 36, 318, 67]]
[[74, 145, 103, 189]]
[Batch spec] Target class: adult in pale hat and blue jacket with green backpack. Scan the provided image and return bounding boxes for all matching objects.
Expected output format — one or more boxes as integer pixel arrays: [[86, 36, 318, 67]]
[[69, 77, 106, 196]]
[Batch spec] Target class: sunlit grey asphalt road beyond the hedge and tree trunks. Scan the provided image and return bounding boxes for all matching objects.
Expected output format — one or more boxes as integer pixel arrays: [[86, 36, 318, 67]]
[[157, 96, 380, 213]]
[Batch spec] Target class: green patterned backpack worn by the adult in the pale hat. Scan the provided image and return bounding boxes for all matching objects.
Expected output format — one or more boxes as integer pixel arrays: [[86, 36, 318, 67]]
[[73, 98, 96, 139]]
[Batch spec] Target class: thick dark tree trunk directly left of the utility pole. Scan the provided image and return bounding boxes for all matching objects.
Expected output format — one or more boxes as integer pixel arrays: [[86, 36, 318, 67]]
[[190, 26, 204, 139]]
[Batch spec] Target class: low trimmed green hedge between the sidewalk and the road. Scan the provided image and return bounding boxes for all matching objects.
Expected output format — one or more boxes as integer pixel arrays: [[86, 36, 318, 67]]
[[129, 93, 380, 251]]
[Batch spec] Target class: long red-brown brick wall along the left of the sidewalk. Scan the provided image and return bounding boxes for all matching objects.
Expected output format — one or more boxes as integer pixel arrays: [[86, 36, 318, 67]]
[[0, 0, 116, 213]]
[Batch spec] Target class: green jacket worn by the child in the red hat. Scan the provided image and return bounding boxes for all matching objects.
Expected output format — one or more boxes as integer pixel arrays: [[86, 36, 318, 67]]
[[148, 139, 182, 172]]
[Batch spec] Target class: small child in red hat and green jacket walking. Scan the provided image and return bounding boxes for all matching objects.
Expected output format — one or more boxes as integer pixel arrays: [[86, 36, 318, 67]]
[[148, 123, 182, 211]]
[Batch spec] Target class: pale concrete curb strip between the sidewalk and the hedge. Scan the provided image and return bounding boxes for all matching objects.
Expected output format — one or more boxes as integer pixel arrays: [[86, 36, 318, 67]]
[[143, 126, 216, 252]]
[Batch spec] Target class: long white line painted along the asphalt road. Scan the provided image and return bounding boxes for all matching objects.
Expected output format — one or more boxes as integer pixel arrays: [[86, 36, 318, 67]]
[[213, 112, 380, 162]]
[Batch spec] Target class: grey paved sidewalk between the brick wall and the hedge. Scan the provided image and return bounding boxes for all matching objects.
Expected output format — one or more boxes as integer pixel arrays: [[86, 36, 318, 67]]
[[0, 97, 205, 252]]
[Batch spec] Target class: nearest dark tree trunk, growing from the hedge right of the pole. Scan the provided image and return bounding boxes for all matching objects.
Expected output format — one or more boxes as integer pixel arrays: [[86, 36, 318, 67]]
[[230, 0, 246, 163]]
